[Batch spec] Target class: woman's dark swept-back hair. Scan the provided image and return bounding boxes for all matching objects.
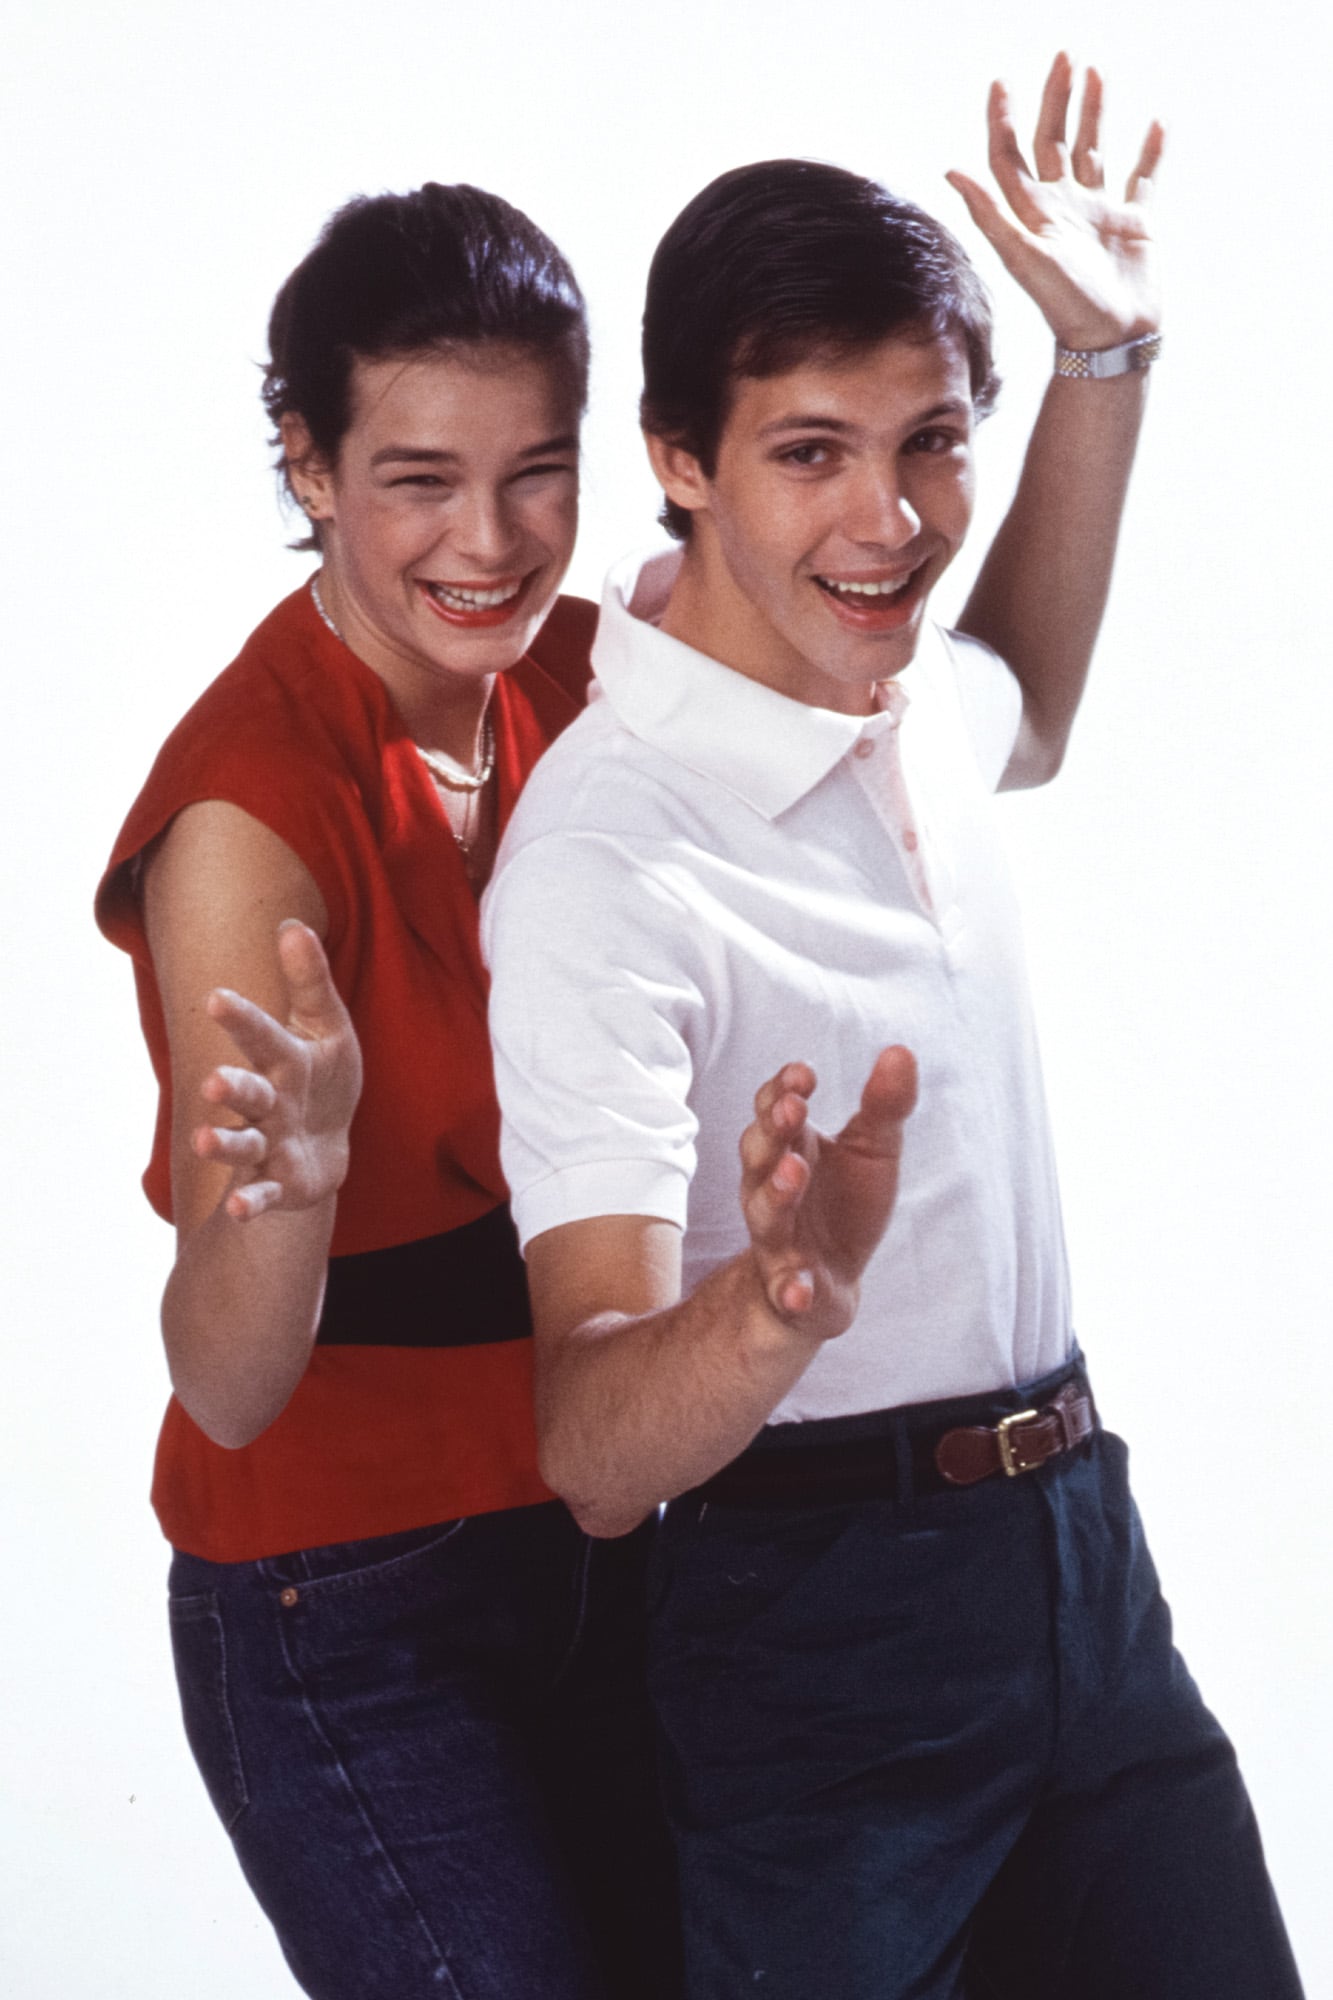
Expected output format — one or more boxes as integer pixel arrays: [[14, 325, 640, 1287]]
[[262, 180, 588, 548]]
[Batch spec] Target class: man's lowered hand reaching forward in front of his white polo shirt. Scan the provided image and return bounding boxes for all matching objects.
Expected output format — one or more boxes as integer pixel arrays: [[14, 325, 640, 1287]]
[[741, 1048, 917, 1340]]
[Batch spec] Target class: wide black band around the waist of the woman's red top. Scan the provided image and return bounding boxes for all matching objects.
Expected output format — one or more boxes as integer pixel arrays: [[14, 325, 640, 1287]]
[[314, 1202, 532, 1348]]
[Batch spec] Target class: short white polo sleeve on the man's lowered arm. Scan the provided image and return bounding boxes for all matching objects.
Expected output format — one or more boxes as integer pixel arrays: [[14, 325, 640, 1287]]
[[482, 832, 705, 1248]]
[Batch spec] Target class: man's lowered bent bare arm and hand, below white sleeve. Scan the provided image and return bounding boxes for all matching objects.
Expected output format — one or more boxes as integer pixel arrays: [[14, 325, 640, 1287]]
[[528, 1048, 917, 1536]]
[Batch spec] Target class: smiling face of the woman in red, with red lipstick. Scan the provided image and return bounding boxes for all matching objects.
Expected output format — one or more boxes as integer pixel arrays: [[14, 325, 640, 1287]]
[[284, 344, 578, 726]]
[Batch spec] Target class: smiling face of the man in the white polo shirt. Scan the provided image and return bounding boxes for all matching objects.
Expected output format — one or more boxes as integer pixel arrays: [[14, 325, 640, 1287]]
[[648, 324, 973, 714]]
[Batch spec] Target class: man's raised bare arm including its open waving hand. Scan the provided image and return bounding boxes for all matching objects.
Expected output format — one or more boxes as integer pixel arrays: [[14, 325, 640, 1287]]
[[949, 56, 1163, 786]]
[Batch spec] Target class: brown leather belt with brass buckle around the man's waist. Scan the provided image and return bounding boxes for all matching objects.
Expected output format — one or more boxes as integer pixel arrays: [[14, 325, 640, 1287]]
[[683, 1366, 1097, 1506]]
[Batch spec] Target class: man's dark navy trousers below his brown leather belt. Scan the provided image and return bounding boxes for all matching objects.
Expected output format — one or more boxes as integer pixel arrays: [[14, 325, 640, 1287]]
[[650, 1368, 1301, 2000]]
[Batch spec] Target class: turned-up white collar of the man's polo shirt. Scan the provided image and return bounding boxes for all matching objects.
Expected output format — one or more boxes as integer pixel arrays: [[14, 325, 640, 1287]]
[[592, 548, 907, 820]]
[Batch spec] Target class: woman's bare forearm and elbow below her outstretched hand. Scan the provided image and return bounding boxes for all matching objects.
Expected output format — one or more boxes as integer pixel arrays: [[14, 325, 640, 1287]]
[[162, 1194, 336, 1448]]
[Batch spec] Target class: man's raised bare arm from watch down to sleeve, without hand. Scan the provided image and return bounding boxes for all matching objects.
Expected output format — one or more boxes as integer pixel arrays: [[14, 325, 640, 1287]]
[[959, 372, 1147, 784]]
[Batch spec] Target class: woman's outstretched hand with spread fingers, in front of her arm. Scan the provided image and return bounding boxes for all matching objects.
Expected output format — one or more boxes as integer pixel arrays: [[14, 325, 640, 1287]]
[[194, 920, 360, 1222]]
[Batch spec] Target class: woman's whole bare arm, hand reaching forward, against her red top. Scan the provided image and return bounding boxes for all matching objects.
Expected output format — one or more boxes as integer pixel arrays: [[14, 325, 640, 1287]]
[[144, 802, 360, 1448]]
